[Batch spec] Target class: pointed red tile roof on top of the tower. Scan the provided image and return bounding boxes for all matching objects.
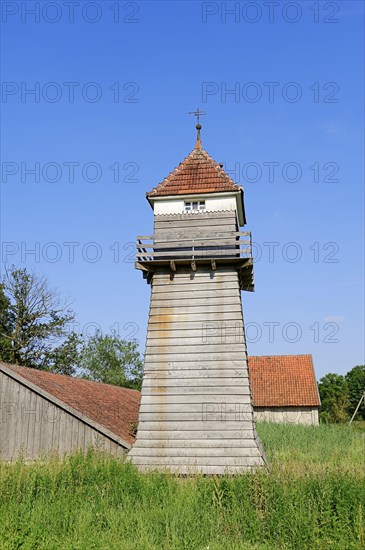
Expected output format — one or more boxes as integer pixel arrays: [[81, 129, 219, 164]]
[[147, 137, 242, 199]]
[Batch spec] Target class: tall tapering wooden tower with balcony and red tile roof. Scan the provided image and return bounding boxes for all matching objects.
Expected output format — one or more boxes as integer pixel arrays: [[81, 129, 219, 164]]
[[129, 123, 266, 474]]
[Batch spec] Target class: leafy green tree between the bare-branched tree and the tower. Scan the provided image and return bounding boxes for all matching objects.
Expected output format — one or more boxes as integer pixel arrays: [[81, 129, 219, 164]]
[[80, 332, 143, 390]]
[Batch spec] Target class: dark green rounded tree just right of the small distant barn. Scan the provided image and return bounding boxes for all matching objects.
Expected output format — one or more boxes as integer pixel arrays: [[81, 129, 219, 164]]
[[318, 373, 349, 423]]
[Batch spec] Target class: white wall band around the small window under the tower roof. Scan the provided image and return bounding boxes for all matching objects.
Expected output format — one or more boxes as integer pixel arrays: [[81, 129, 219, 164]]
[[153, 195, 237, 216]]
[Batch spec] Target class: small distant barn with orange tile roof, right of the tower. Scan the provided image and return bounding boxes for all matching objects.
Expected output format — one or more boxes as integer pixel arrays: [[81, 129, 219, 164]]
[[248, 355, 320, 425]]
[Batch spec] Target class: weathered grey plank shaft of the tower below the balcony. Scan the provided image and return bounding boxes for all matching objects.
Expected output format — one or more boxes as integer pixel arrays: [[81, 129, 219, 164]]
[[130, 262, 265, 473]]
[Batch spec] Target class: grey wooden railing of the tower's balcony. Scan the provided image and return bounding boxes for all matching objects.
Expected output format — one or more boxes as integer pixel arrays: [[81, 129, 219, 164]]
[[136, 231, 252, 263]]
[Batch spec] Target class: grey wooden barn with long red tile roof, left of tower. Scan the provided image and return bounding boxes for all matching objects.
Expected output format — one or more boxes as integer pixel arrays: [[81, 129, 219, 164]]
[[0, 363, 140, 460]]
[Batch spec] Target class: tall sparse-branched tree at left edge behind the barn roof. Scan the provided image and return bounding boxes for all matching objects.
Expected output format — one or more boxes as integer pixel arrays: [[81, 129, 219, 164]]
[[0, 267, 80, 374]]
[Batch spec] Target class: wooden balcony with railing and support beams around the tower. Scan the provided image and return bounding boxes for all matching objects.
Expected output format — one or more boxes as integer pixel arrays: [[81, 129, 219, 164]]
[[135, 231, 254, 291]]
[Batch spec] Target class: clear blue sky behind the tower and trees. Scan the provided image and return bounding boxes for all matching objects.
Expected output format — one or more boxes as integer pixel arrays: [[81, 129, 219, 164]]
[[1, 0, 364, 377]]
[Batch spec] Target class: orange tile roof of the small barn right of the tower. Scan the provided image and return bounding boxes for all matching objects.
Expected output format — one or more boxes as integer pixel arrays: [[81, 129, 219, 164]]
[[248, 355, 320, 407]]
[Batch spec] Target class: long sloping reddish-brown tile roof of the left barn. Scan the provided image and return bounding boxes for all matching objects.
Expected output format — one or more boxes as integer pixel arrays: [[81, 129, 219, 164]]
[[0, 364, 141, 444]]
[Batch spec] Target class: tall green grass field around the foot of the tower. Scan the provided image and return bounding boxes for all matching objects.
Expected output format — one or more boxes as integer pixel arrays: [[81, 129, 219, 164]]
[[0, 424, 365, 550]]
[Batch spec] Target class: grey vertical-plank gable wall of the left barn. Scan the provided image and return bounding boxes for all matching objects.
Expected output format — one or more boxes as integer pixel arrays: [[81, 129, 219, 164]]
[[0, 372, 124, 460]]
